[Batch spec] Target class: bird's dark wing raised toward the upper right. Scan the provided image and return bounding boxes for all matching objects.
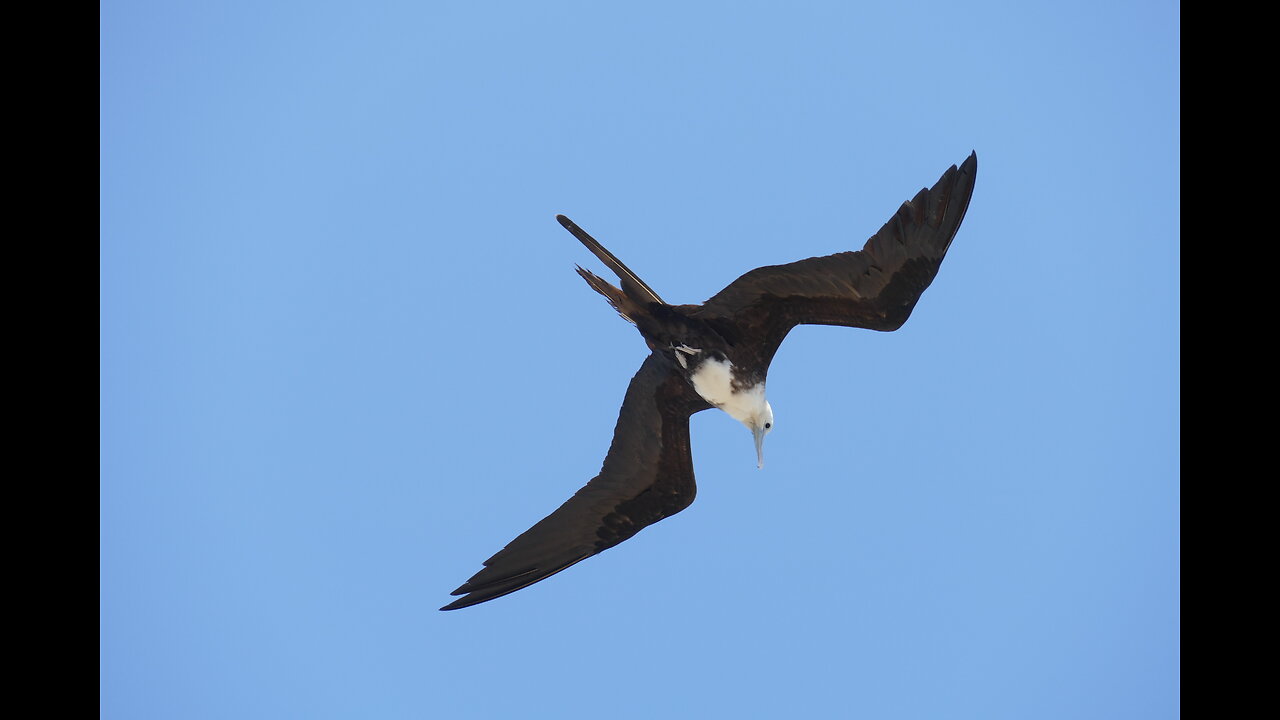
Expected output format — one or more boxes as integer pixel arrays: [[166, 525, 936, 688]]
[[695, 152, 978, 366]]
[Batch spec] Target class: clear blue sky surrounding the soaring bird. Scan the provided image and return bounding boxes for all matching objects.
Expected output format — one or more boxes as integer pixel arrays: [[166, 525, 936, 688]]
[[100, 0, 1180, 720]]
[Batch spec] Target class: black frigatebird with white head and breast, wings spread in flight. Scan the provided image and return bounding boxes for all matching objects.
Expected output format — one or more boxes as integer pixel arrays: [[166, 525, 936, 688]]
[[440, 151, 978, 610]]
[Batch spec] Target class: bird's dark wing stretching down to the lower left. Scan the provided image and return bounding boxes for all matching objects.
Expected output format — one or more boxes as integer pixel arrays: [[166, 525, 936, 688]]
[[440, 354, 710, 610]]
